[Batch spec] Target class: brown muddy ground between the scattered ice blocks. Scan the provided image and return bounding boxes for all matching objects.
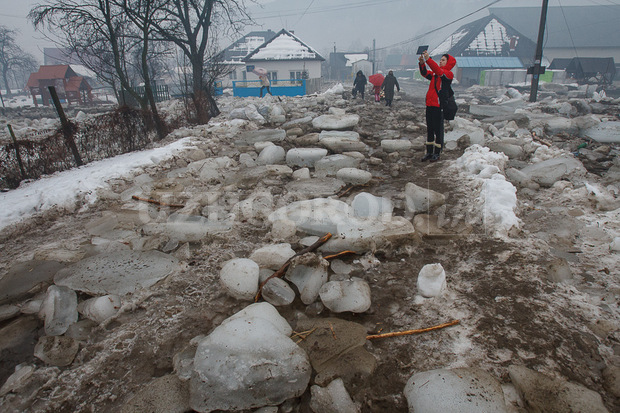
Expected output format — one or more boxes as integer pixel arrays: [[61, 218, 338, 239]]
[[0, 91, 620, 412]]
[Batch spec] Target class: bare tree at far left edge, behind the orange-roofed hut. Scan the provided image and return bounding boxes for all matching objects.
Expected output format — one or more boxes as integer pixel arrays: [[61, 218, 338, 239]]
[[0, 26, 37, 97]]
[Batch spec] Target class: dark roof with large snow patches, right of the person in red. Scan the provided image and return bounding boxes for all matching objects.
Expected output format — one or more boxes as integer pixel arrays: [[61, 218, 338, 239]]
[[431, 15, 536, 62]]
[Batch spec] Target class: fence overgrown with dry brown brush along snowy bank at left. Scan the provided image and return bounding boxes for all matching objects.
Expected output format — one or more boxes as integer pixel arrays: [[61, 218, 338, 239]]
[[0, 107, 160, 188]]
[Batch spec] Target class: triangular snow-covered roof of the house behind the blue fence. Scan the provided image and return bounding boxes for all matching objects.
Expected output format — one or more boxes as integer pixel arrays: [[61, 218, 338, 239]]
[[243, 29, 325, 62]]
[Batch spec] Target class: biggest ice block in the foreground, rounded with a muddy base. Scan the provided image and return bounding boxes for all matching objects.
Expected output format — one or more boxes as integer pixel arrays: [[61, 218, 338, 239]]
[[190, 303, 312, 412]]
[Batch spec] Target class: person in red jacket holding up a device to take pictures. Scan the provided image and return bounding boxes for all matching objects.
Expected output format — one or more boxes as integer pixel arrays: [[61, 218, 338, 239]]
[[419, 50, 456, 162]]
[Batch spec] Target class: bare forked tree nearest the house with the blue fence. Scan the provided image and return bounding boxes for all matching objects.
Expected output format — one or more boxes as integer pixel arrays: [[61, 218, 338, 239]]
[[153, 0, 251, 123]]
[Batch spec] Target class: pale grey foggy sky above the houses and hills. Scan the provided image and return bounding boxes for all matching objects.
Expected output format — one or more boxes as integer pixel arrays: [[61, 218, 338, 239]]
[[0, 0, 600, 63]]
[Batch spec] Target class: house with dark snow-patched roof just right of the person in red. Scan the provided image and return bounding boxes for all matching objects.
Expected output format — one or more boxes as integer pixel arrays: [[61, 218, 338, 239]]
[[430, 15, 536, 85]]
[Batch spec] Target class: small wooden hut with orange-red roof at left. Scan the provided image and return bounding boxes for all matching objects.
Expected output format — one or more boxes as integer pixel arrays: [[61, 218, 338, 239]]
[[26, 65, 93, 106]]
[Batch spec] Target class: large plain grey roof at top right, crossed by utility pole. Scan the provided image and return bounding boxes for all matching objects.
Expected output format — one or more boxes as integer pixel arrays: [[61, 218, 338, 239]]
[[489, 4, 620, 48]]
